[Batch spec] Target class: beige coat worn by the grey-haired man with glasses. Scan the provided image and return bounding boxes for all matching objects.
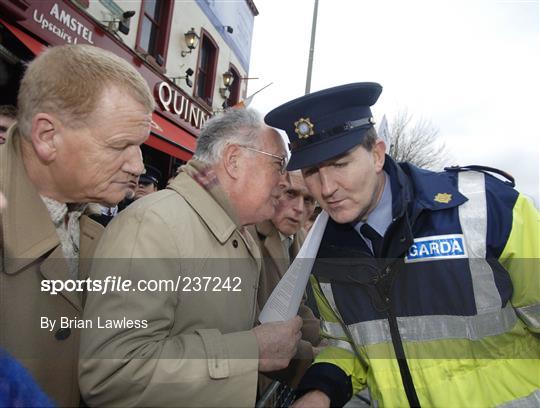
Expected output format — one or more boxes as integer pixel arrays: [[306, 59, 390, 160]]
[[79, 164, 260, 407]]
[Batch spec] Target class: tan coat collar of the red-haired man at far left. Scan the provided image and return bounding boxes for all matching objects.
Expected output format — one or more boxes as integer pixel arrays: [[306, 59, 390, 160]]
[[0, 125, 103, 279]]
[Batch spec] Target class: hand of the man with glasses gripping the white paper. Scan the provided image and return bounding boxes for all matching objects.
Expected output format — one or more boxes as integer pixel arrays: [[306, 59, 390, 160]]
[[253, 316, 302, 372]]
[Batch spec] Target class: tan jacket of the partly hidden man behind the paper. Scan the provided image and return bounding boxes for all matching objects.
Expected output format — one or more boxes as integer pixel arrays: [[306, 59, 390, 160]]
[[250, 221, 320, 386]]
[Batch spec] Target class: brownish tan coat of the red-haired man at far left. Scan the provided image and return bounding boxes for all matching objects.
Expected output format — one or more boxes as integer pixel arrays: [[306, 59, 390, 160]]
[[0, 128, 103, 406]]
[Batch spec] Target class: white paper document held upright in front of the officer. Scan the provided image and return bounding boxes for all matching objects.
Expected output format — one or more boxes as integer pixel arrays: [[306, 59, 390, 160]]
[[259, 211, 328, 323]]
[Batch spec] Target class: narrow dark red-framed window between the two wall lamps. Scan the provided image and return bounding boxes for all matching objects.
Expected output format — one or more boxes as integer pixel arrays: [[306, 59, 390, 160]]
[[195, 30, 218, 106]]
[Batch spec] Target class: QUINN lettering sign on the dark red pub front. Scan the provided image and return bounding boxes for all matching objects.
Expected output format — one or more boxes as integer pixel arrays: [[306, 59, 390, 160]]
[[156, 82, 209, 129]]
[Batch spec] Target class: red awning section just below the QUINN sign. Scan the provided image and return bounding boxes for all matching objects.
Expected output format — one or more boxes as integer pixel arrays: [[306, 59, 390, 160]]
[[146, 112, 197, 161]]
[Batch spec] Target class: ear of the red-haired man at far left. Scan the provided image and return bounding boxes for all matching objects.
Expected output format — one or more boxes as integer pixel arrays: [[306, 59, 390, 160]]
[[31, 113, 61, 163]]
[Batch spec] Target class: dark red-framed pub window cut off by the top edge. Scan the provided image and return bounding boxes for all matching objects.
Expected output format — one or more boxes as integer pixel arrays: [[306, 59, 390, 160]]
[[136, 0, 174, 67]]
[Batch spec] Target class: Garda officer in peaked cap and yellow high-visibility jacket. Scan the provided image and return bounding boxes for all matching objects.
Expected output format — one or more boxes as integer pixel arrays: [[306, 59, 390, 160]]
[[265, 83, 540, 407]]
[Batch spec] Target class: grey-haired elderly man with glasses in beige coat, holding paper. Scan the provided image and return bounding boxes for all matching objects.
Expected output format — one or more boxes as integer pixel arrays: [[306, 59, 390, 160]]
[[79, 109, 302, 407]]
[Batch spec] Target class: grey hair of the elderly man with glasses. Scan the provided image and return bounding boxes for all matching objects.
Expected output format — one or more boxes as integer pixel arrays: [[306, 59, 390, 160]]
[[194, 108, 266, 165]]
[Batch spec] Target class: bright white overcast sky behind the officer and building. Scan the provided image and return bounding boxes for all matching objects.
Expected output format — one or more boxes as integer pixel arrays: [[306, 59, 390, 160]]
[[248, 0, 540, 207]]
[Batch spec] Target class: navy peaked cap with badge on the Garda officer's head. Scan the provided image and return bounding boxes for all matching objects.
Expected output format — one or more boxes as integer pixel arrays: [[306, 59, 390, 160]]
[[264, 82, 382, 170]]
